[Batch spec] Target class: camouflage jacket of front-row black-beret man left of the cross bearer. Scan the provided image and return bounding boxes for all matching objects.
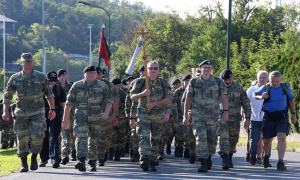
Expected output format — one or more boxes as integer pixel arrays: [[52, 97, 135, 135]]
[[66, 79, 113, 121]]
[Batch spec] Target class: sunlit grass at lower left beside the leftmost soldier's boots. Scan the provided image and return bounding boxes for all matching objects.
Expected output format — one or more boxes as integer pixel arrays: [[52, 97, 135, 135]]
[[0, 148, 39, 177]]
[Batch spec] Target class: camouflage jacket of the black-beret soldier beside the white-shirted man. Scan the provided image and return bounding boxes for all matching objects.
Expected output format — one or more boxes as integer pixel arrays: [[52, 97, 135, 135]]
[[226, 81, 251, 120]]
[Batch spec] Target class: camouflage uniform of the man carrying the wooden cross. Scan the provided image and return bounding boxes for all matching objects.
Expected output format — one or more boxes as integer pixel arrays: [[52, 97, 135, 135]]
[[130, 78, 173, 162]]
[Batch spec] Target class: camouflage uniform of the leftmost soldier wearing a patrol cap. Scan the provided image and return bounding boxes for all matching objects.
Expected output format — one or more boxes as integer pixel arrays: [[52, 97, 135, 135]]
[[4, 70, 54, 157]]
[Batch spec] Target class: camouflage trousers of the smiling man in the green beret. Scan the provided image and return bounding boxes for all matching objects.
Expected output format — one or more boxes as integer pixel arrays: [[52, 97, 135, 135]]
[[192, 115, 219, 159]]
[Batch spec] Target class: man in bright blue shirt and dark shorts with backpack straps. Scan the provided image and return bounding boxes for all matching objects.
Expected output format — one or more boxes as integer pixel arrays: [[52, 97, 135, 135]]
[[253, 71, 297, 170]]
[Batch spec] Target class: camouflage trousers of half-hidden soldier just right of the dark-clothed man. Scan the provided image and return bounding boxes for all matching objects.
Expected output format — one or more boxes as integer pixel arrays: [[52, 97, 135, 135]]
[[61, 117, 76, 157]]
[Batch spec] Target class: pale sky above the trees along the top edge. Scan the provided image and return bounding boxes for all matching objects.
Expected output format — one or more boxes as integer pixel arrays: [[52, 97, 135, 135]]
[[128, 0, 297, 18]]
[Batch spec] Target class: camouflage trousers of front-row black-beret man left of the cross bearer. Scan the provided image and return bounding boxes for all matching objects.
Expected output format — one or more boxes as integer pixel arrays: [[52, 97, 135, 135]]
[[74, 118, 102, 160]]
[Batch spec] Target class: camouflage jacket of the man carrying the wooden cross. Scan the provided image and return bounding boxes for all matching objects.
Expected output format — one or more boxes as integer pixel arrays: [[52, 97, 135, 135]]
[[130, 77, 173, 118]]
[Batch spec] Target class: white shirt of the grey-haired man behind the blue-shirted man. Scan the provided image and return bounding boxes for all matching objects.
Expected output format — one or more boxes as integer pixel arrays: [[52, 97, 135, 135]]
[[247, 85, 264, 121]]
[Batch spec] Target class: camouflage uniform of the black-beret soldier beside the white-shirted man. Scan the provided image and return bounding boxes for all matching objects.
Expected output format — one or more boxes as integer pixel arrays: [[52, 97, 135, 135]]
[[219, 81, 251, 156]]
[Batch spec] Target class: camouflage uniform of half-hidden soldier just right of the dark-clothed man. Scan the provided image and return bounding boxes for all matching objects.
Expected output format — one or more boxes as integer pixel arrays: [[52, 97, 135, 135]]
[[61, 82, 76, 157]]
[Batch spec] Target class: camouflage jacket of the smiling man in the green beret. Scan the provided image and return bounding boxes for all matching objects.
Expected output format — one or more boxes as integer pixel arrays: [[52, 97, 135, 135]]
[[186, 75, 227, 117]]
